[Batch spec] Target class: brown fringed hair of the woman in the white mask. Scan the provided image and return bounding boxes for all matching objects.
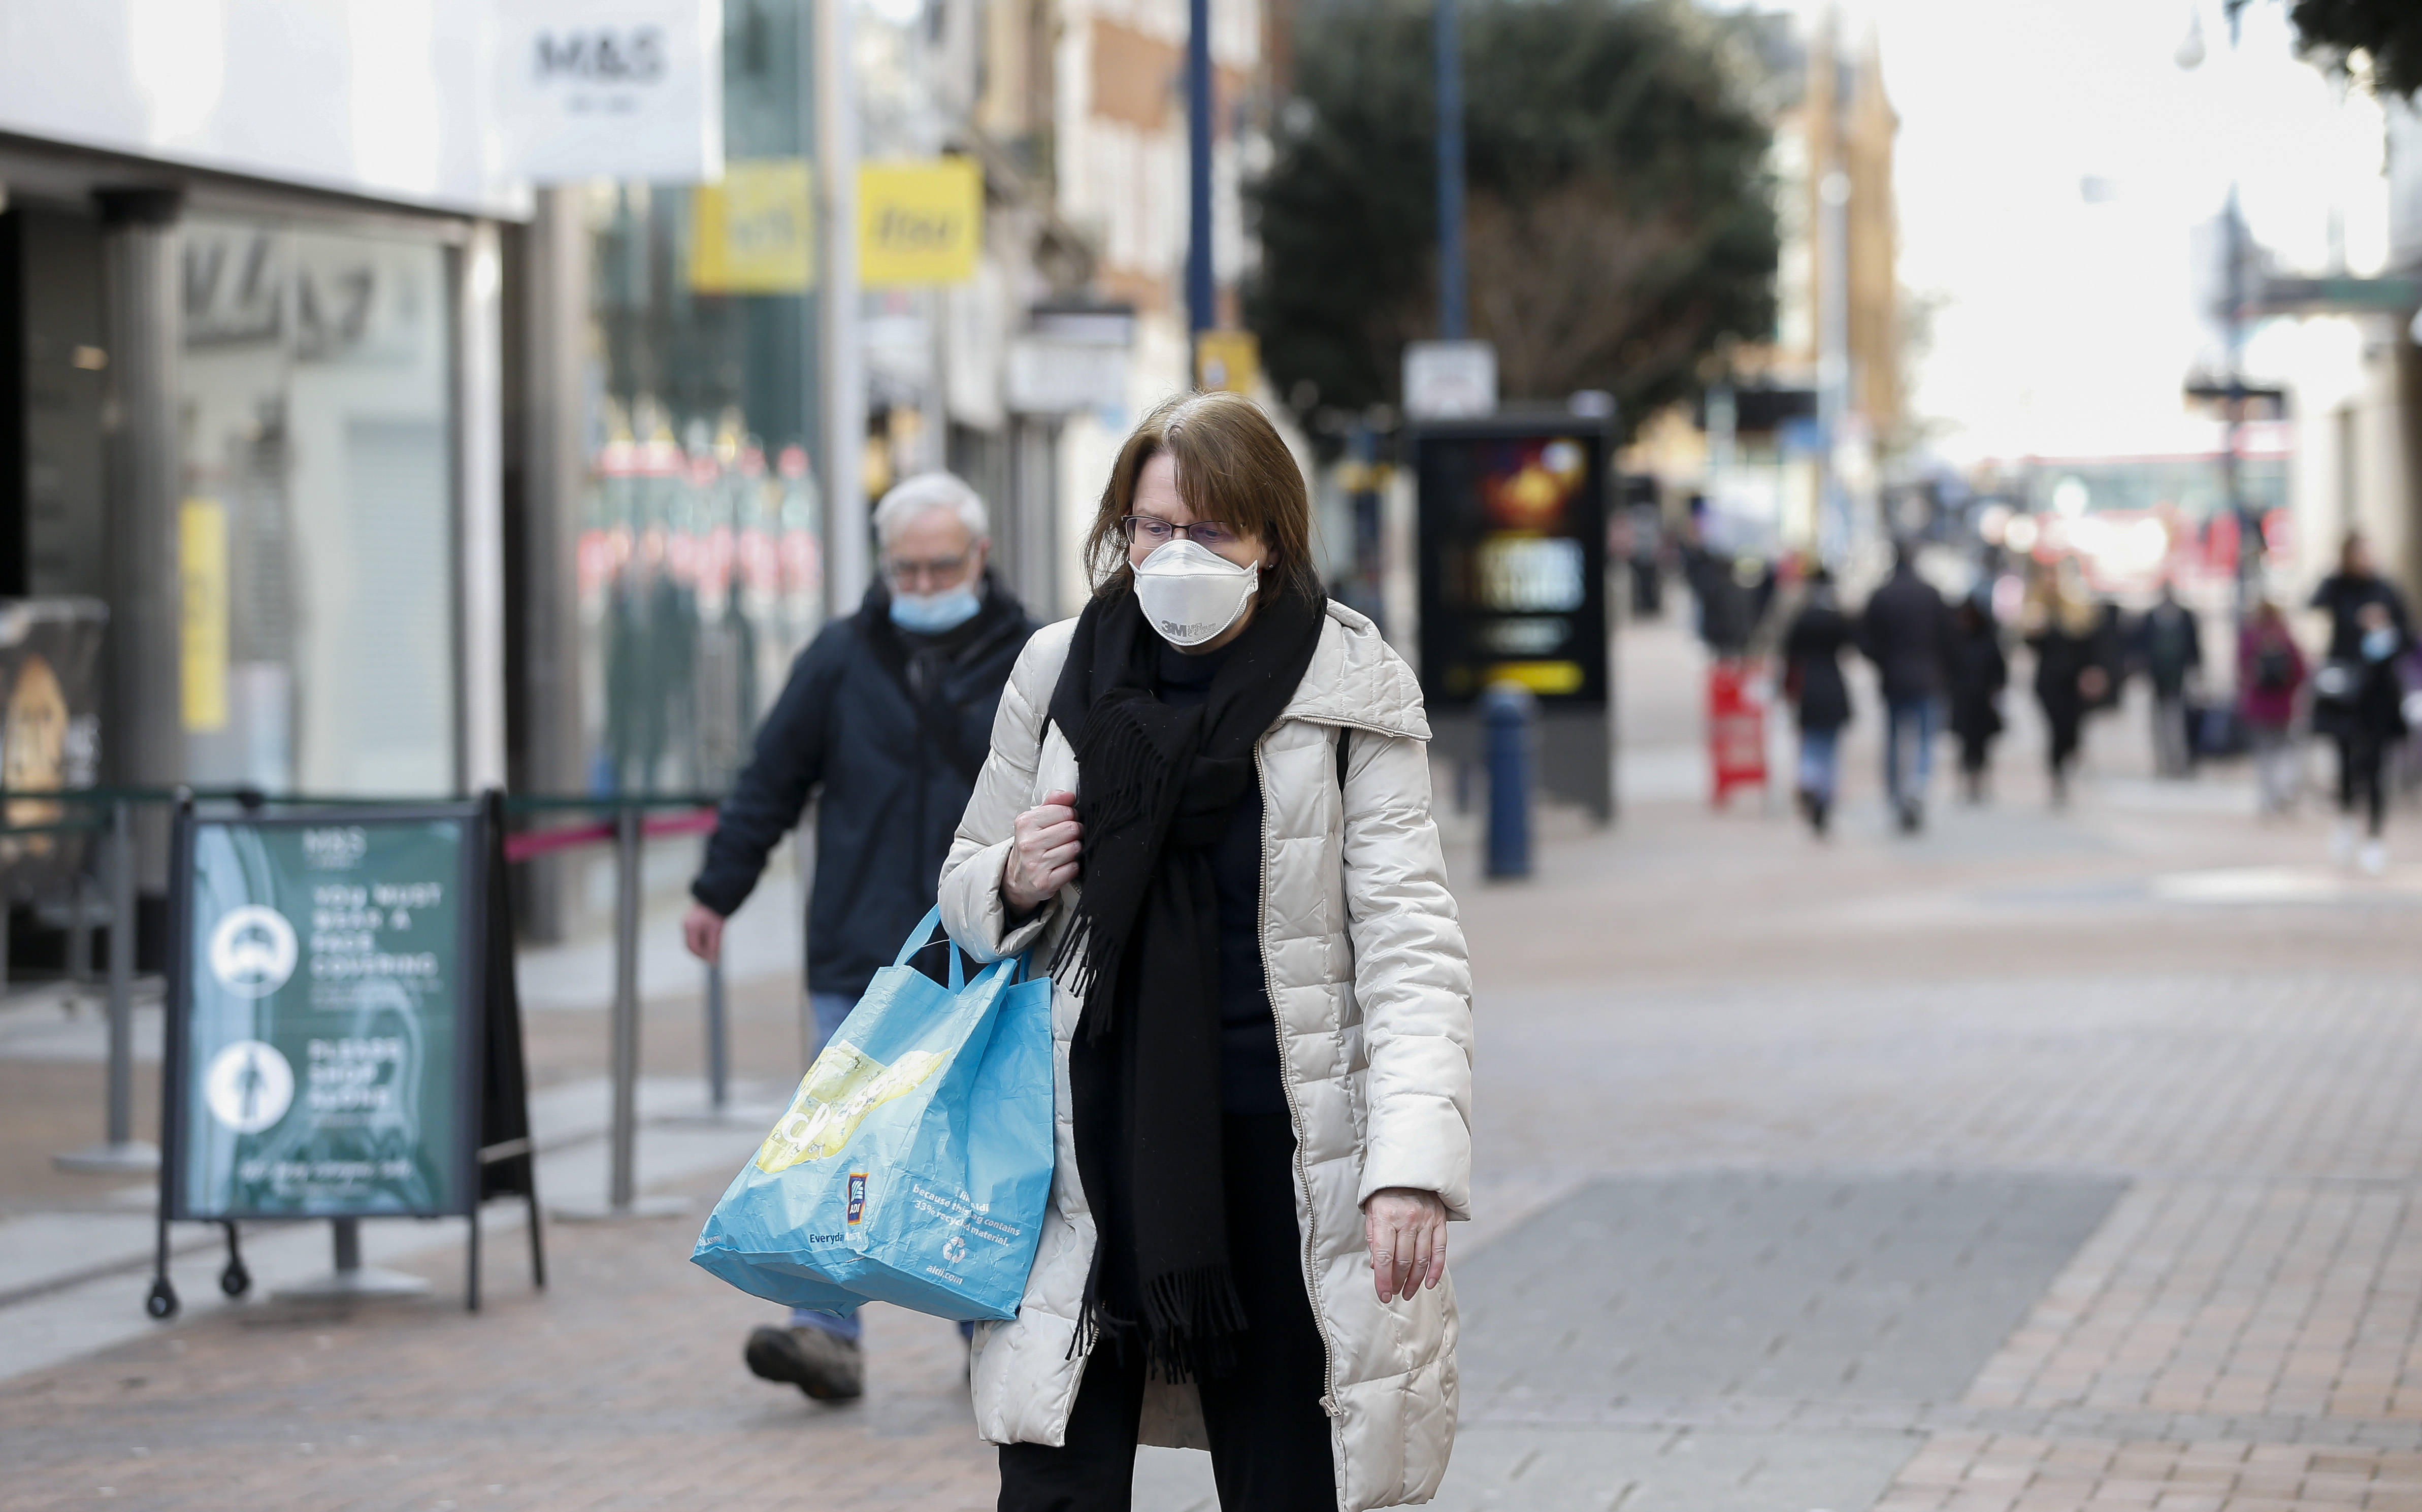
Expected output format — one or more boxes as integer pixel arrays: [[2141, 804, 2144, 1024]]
[[1085, 390, 1322, 599]]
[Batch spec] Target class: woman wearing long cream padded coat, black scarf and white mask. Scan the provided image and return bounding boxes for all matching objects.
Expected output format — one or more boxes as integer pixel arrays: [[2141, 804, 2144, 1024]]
[[942, 392, 1472, 1512]]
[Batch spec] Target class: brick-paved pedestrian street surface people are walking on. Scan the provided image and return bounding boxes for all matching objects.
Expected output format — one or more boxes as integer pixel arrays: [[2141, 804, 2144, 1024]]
[[0, 628, 2422, 1512]]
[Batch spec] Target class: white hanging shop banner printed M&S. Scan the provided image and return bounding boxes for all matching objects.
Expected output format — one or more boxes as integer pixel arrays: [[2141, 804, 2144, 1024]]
[[494, 0, 724, 184]]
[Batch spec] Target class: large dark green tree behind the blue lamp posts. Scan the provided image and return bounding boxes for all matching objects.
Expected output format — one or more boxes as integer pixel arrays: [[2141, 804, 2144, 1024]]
[[1245, 0, 1778, 429]]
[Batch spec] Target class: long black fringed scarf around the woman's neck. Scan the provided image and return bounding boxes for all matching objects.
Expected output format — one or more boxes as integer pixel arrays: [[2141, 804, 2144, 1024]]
[[1051, 572, 1325, 1381]]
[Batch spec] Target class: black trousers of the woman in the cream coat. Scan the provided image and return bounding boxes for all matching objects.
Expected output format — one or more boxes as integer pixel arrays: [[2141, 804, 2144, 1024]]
[[1000, 1112, 1337, 1512]]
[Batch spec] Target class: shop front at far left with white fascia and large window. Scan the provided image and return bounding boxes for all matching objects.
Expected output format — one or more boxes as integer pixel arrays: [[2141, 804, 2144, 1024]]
[[0, 0, 528, 911]]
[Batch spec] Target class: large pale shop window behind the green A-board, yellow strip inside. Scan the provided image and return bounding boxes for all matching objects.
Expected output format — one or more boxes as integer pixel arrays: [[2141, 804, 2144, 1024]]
[[177, 218, 455, 797]]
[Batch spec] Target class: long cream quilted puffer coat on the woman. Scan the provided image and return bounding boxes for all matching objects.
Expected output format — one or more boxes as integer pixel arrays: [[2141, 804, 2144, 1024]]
[[942, 603, 1472, 1512]]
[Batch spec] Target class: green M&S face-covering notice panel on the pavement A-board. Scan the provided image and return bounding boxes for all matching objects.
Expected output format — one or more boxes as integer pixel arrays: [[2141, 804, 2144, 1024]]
[[167, 807, 487, 1219]]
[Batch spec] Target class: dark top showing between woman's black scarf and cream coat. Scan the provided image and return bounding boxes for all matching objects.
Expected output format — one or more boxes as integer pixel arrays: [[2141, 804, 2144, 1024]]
[[1158, 644, 1286, 1112]]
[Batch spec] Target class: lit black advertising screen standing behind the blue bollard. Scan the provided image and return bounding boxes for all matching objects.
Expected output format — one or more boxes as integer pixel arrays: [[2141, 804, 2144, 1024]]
[[1412, 417, 1606, 705]]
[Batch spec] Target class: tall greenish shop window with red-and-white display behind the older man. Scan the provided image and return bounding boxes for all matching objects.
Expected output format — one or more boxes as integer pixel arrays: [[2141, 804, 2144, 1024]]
[[579, 0, 824, 793]]
